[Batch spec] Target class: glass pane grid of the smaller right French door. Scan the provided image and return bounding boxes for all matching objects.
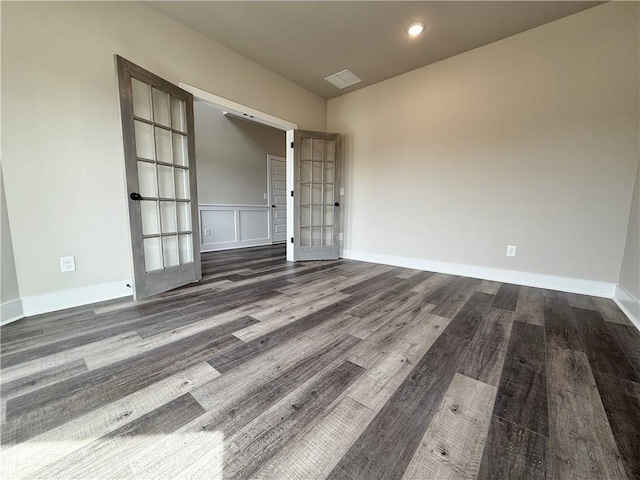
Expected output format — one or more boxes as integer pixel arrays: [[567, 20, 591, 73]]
[[300, 137, 336, 247]]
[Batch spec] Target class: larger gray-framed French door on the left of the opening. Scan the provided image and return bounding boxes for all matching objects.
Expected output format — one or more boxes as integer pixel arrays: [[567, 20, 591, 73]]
[[116, 55, 202, 300]]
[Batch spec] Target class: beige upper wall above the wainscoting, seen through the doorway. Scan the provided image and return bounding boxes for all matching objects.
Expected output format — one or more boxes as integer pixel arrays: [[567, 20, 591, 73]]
[[195, 102, 286, 205]]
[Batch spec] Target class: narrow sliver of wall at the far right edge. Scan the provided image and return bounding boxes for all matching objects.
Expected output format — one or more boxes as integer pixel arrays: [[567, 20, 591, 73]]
[[618, 159, 640, 300]]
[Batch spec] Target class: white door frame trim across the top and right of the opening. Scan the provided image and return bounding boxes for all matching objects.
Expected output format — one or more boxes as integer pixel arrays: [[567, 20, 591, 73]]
[[178, 82, 298, 262]]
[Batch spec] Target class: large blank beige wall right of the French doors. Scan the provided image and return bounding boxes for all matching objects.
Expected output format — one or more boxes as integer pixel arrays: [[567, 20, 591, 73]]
[[327, 2, 639, 283]]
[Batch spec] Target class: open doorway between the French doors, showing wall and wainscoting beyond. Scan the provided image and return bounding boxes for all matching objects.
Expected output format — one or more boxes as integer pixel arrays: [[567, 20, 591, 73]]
[[194, 101, 286, 257]]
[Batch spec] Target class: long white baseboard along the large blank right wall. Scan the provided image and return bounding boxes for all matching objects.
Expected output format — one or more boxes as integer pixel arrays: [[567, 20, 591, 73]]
[[341, 250, 615, 298]]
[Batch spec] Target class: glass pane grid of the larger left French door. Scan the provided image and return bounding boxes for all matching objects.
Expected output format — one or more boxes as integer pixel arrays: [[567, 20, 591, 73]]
[[131, 78, 193, 272]]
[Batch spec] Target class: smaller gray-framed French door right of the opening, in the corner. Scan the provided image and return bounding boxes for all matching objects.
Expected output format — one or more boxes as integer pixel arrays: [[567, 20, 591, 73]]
[[292, 130, 341, 260]]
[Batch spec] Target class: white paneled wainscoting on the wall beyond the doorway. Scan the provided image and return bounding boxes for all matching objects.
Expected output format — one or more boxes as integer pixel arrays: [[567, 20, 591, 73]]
[[198, 205, 271, 252]]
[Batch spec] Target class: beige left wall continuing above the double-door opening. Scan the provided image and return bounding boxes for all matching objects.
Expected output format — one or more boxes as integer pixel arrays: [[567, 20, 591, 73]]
[[1, 2, 326, 296]]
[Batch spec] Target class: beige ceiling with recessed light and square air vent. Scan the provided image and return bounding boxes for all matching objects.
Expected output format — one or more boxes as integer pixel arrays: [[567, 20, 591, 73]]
[[145, 0, 604, 99]]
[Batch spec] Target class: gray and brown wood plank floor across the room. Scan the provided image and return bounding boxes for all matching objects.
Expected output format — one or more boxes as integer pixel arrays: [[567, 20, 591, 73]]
[[0, 246, 640, 480]]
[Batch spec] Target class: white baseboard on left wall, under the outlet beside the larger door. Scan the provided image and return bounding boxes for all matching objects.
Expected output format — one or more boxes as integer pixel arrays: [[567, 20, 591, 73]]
[[22, 280, 133, 317]]
